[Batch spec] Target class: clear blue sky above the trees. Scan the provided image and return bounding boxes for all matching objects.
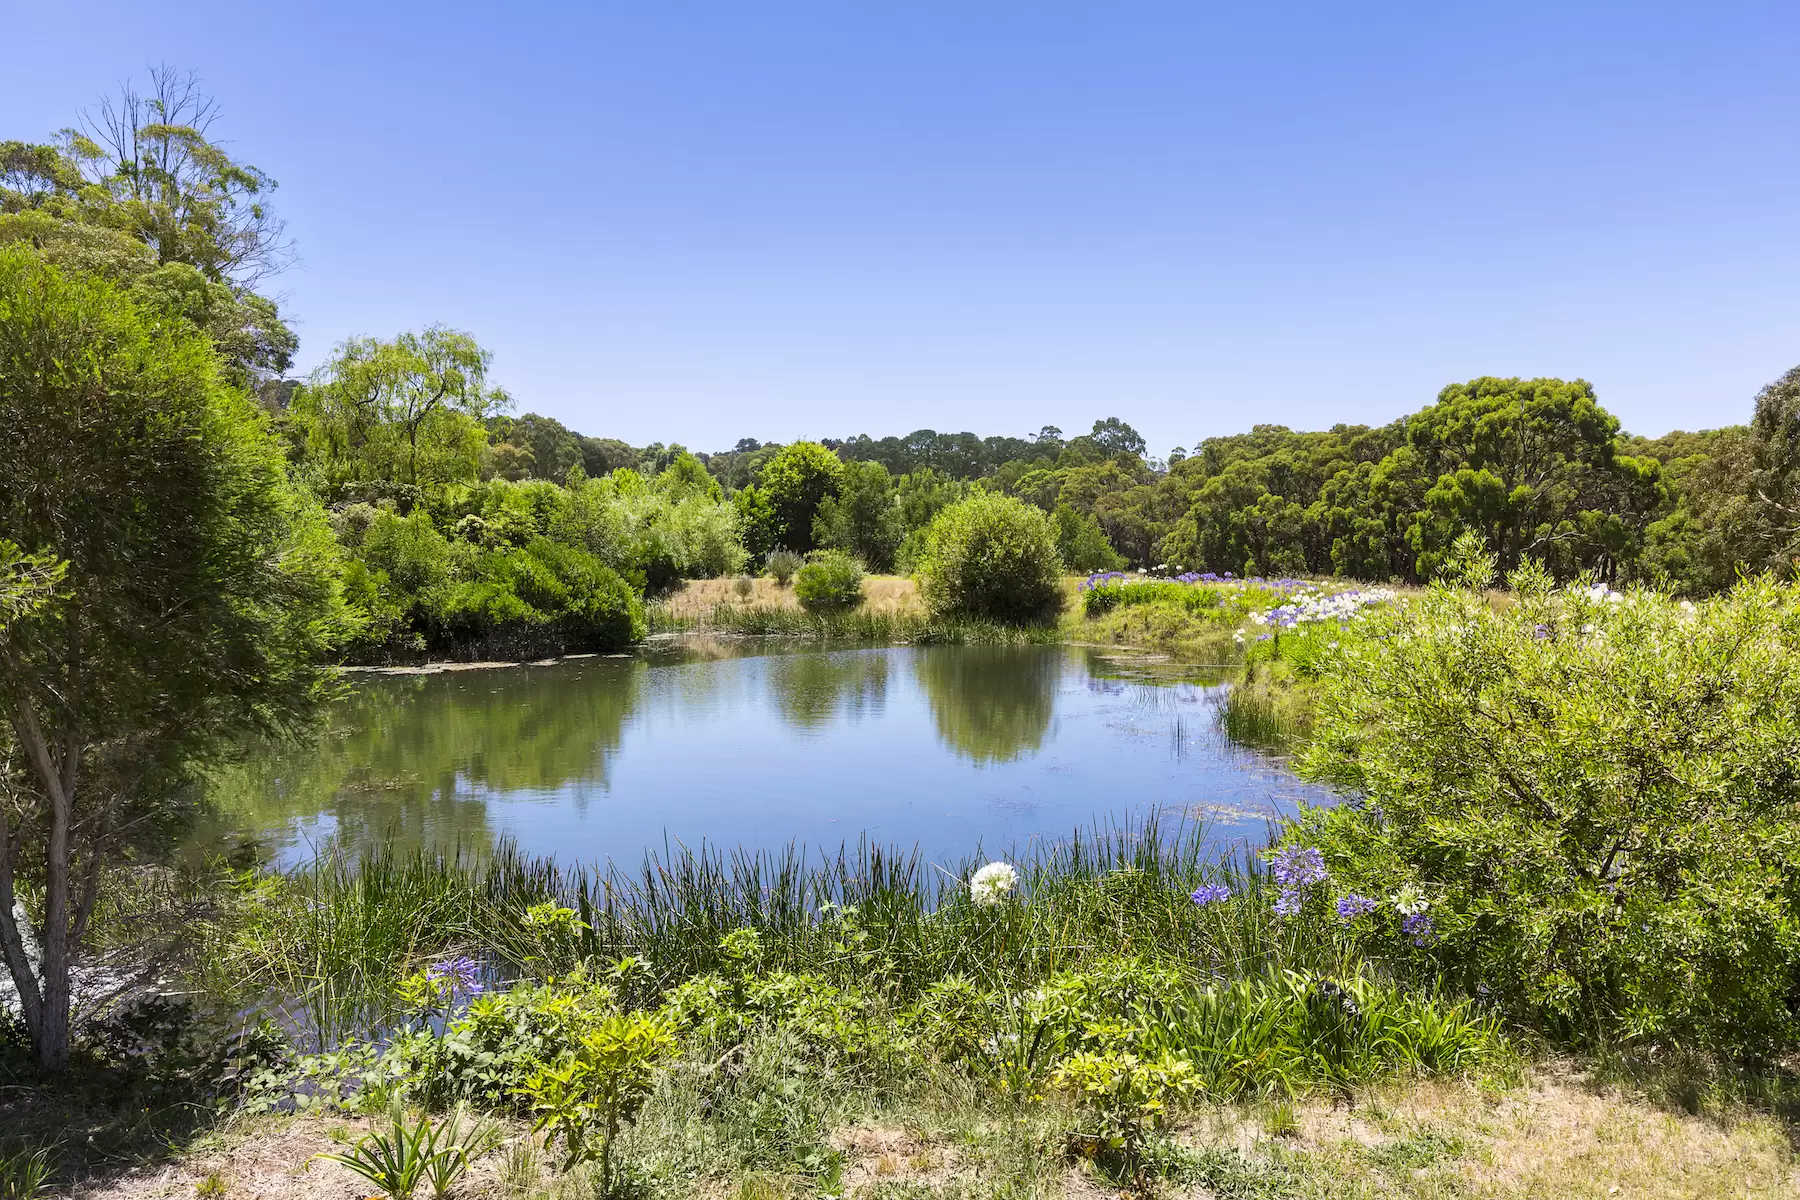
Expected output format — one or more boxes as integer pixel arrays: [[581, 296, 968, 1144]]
[[0, 0, 1800, 452]]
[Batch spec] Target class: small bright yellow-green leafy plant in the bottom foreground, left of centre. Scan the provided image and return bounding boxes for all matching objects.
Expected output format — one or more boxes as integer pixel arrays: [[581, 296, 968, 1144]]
[[526, 1013, 675, 1196]]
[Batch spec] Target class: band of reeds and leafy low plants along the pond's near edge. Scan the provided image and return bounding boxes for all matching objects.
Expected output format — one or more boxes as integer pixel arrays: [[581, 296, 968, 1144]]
[[171, 822, 1514, 1193]]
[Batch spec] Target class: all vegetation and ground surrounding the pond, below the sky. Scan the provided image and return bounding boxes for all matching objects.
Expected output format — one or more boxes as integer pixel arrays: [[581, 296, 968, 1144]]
[[10, 70, 1800, 1200]]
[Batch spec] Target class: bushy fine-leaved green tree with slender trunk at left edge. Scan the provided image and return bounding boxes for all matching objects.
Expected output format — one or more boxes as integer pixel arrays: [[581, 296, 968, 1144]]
[[0, 246, 349, 1069]]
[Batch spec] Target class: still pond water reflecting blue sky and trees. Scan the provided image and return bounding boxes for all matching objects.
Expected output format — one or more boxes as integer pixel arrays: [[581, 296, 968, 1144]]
[[209, 639, 1327, 865]]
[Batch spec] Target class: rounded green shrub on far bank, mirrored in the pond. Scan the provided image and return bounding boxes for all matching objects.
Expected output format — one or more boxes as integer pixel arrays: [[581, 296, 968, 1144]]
[[920, 491, 1062, 624]]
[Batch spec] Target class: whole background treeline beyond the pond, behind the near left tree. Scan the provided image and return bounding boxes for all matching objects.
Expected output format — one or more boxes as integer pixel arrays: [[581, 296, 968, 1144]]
[[0, 72, 1800, 672]]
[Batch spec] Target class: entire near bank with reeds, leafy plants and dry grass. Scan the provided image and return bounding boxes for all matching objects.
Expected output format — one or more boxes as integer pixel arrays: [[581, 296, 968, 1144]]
[[14, 822, 1800, 1200]]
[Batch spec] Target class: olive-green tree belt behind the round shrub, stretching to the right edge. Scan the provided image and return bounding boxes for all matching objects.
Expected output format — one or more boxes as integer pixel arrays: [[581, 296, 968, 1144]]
[[468, 369, 1800, 594]]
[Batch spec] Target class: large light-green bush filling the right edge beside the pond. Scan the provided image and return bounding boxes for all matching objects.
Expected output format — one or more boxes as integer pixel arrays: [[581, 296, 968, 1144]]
[[1296, 567, 1800, 1049]]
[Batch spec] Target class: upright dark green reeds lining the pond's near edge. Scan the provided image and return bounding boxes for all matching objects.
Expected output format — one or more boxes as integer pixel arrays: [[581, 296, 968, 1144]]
[[203, 815, 1343, 1043]]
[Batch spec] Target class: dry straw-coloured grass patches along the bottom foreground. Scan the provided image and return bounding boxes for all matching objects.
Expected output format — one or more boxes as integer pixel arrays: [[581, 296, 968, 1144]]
[[67, 1067, 1800, 1200]]
